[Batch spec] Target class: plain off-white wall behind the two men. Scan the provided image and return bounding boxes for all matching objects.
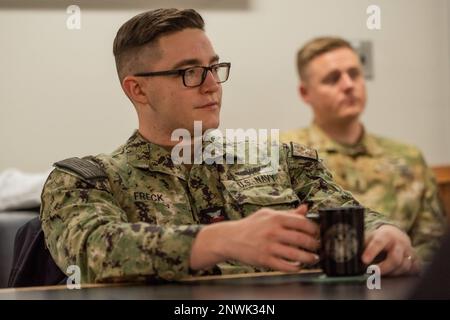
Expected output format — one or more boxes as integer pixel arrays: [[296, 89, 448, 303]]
[[0, 0, 450, 171]]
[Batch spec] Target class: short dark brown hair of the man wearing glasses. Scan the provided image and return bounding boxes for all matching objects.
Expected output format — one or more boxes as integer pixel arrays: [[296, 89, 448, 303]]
[[113, 8, 205, 81]]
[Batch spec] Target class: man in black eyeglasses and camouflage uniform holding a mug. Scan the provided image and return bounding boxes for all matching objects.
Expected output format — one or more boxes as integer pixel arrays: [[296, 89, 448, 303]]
[[41, 9, 417, 282]]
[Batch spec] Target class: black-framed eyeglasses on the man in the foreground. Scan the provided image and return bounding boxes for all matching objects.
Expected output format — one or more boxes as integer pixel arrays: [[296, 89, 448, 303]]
[[134, 62, 231, 88]]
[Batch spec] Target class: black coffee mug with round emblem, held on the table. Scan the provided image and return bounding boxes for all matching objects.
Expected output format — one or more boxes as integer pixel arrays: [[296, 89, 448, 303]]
[[319, 206, 365, 277]]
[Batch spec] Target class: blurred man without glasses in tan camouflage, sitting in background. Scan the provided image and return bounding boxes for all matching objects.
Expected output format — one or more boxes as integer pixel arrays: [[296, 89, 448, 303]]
[[281, 37, 446, 261]]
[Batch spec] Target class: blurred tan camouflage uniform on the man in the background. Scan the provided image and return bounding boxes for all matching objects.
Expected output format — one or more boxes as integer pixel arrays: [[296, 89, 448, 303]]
[[280, 124, 446, 261]]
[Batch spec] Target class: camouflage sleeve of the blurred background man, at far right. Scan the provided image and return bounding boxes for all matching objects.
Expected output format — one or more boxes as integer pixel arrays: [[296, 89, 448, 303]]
[[410, 155, 447, 262]]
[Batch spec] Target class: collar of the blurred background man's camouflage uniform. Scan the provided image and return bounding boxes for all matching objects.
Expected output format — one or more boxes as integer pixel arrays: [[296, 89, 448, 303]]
[[308, 123, 383, 157]]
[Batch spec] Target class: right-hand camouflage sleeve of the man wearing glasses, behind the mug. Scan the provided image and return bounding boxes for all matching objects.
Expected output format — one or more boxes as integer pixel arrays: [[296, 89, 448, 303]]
[[285, 146, 395, 231]]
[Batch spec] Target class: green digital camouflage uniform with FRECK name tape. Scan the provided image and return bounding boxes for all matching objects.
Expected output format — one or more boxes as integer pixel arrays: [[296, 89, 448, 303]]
[[41, 132, 386, 282]]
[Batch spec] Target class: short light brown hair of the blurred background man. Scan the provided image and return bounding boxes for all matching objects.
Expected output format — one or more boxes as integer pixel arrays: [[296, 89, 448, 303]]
[[297, 37, 355, 81]]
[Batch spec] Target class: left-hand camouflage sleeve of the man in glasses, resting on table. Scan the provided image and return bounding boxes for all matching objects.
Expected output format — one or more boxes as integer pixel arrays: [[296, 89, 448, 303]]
[[41, 169, 205, 283]]
